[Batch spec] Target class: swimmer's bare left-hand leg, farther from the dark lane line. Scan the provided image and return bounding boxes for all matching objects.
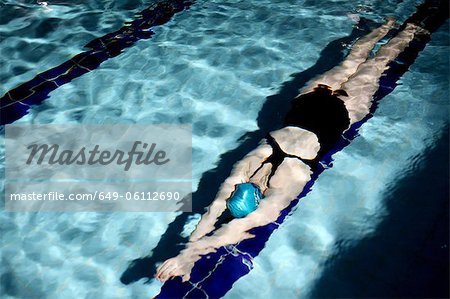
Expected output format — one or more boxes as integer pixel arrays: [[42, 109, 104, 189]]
[[300, 18, 395, 94]]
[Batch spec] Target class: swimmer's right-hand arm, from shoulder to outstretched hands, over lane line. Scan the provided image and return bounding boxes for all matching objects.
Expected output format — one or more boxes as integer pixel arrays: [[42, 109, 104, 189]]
[[157, 158, 312, 281]]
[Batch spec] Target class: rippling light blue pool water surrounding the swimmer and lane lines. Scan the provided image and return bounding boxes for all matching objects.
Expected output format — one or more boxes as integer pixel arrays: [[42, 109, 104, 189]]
[[0, 0, 449, 298]]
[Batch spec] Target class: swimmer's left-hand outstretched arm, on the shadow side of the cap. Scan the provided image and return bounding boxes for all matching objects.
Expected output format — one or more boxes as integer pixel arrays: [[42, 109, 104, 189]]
[[189, 142, 272, 242]]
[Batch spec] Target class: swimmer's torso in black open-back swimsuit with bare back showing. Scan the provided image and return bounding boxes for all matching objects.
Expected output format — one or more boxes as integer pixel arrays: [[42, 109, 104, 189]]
[[253, 85, 350, 190]]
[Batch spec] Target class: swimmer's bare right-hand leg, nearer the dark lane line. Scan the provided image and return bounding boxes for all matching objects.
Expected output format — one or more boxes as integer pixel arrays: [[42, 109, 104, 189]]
[[339, 24, 427, 124]]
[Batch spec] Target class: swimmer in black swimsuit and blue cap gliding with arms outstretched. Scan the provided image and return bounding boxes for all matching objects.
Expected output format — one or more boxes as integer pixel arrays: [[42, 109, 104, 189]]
[[156, 0, 449, 281]]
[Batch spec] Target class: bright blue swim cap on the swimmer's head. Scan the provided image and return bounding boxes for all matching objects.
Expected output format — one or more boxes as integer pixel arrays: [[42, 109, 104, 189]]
[[227, 183, 263, 218]]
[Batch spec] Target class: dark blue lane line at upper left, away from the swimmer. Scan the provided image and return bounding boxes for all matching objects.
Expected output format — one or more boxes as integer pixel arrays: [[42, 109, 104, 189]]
[[0, 0, 195, 125]]
